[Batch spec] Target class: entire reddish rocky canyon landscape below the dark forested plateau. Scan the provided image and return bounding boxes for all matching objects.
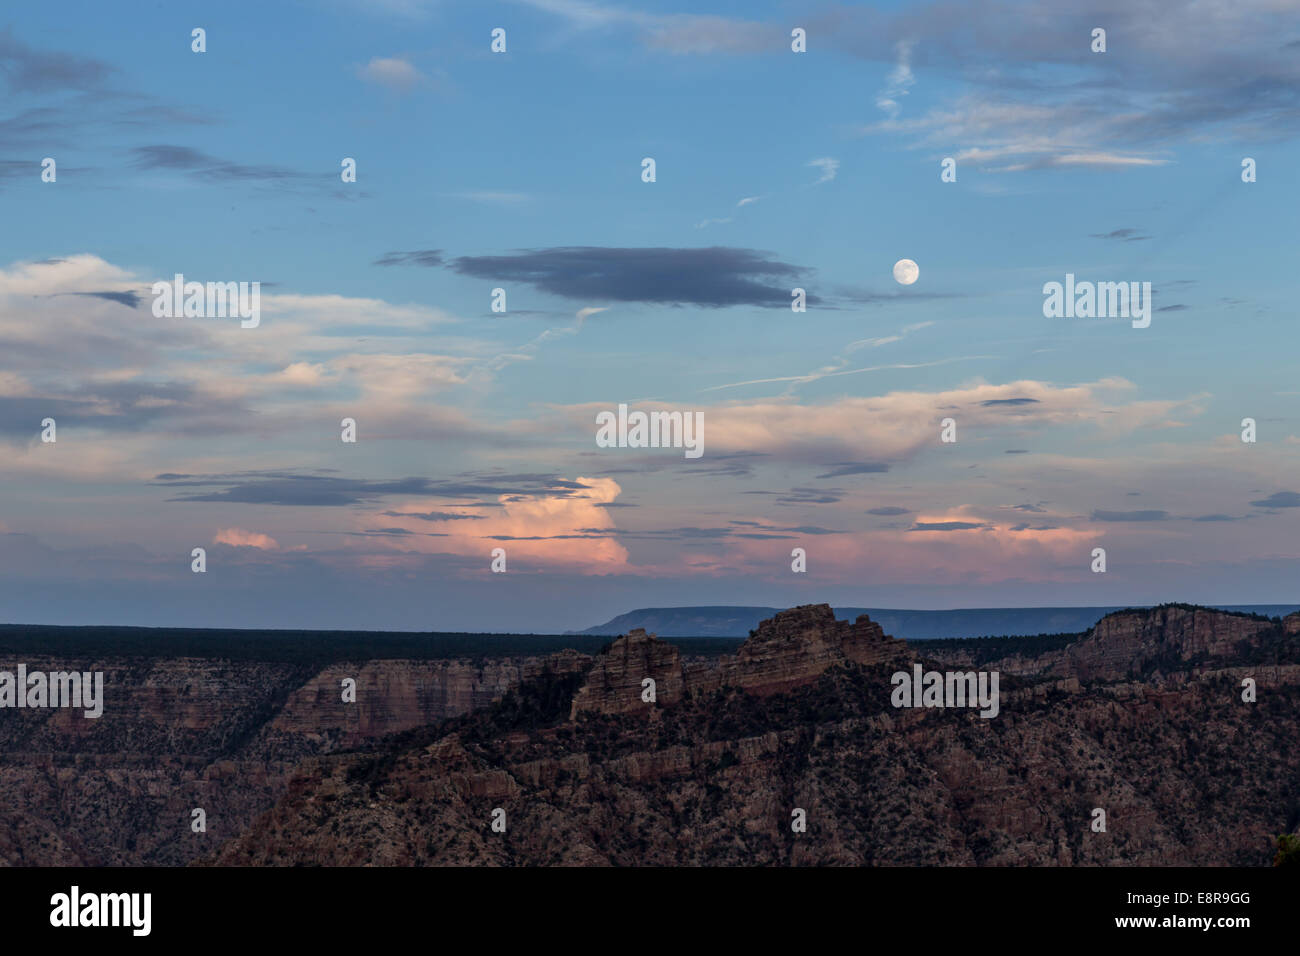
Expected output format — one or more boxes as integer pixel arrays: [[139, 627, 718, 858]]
[[0, 605, 1300, 866]]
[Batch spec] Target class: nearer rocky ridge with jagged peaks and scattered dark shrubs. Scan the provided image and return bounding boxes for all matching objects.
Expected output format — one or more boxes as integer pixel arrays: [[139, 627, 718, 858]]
[[215, 607, 1300, 865]]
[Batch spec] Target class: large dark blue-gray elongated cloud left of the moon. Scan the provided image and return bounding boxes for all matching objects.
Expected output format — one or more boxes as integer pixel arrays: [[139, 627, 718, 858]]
[[447, 246, 818, 308]]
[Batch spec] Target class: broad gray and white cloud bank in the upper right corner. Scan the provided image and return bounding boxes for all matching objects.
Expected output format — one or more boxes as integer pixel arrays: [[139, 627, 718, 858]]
[[842, 0, 1300, 172]]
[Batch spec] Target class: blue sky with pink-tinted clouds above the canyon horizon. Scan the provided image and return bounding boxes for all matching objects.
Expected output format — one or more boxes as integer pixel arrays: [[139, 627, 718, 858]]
[[0, 0, 1300, 632]]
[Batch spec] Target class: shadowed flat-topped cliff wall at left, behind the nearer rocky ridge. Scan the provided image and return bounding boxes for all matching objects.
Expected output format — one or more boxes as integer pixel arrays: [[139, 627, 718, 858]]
[[0, 652, 588, 865]]
